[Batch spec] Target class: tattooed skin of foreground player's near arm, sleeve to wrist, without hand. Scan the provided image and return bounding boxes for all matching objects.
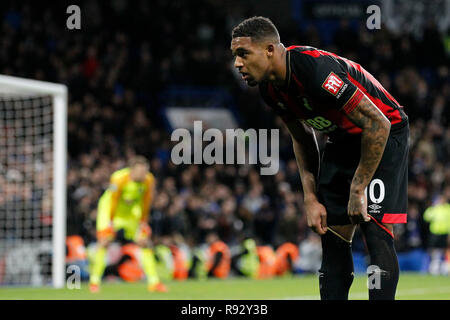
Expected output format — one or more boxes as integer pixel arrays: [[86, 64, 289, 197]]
[[348, 97, 390, 189]]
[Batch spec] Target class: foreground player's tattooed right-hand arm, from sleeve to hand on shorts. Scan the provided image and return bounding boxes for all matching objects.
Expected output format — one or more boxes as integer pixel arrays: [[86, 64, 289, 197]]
[[347, 96, 391, 224]]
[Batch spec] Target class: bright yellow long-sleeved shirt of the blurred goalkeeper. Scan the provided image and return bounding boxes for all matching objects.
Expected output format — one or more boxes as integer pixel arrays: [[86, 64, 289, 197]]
[[97, 168, 155, 238]]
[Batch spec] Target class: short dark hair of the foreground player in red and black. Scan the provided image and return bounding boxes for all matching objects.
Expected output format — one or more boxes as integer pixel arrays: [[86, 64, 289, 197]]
[[231, 17, 280, 42]]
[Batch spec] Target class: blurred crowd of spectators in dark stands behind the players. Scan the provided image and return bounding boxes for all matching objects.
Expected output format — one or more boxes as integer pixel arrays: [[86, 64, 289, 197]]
[[0, 0, 450, 276]]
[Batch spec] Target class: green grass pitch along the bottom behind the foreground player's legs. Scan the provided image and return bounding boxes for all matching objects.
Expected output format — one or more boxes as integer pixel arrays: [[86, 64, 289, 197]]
[[0, 273, 450, 300]]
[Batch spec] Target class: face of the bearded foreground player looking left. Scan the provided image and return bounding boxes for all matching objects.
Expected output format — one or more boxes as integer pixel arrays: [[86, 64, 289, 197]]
[[231, 37, 270, 87]]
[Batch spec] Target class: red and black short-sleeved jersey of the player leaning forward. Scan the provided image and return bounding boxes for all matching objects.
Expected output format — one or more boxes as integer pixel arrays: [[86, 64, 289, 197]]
[[259, 46, 408, 140]]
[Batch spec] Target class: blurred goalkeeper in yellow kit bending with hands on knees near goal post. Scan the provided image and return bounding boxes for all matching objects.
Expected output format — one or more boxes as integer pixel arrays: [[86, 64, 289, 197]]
[[89, 156, 167, 292]]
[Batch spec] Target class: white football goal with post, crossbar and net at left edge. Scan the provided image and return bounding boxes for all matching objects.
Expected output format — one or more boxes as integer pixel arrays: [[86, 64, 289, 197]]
[[0, 75, 67, 288]]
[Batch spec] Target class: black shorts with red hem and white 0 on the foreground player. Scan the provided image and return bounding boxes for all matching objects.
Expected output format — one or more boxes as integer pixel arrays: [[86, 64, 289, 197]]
[[318, 121, 409, 226]]
